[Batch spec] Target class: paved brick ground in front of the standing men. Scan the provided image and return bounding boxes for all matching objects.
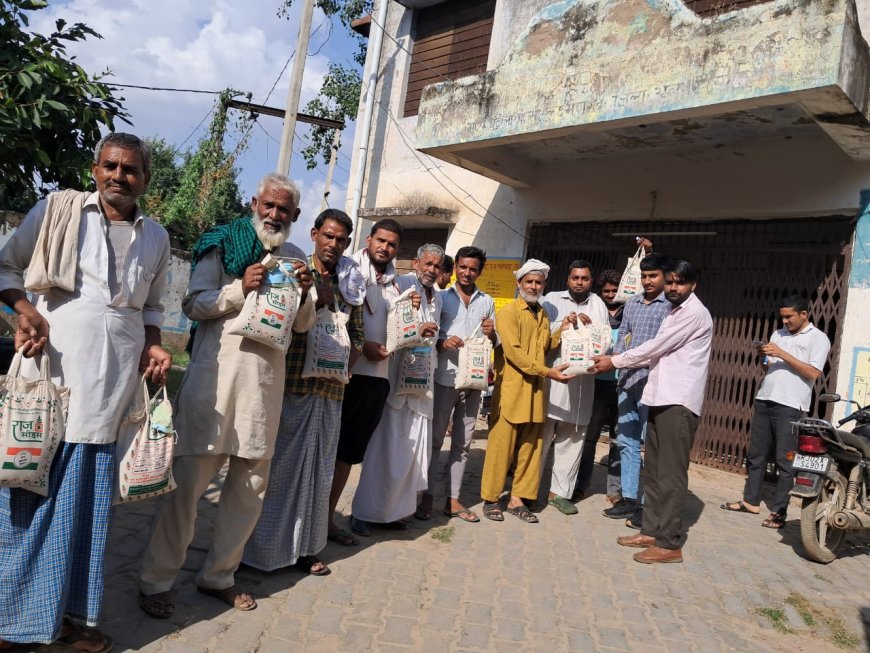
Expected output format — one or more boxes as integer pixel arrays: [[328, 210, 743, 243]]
[[13, 440, 870, 653]]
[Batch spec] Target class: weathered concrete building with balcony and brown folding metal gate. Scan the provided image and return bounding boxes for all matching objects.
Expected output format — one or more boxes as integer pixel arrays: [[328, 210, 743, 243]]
[[350, 0, 870, 469]]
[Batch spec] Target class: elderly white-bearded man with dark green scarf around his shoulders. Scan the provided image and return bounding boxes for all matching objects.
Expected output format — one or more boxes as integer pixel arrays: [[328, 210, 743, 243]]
[[140, 174, 315, 618]]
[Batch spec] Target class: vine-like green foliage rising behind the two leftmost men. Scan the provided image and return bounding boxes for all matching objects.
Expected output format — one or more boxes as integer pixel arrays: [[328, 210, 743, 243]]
[[141, 89, 251, 250]]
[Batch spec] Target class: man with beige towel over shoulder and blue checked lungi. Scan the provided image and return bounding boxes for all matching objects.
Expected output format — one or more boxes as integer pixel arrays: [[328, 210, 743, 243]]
[[0, 133, 171, 653]]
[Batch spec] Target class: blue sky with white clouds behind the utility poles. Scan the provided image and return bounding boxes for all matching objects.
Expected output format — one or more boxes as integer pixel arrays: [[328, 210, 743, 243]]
[[29, 0, 354, 251]]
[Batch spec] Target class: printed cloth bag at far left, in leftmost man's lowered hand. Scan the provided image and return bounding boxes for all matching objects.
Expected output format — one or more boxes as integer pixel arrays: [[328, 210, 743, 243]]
[[0, 351, 69, 496]]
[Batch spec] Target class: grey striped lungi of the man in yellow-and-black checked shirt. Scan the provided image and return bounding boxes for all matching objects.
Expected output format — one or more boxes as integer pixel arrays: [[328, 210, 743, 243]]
[[242, 394, 341, 571]]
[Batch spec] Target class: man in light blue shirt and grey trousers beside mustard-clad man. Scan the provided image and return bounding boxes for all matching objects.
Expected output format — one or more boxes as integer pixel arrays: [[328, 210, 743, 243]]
[[414, 247, 496, 522]]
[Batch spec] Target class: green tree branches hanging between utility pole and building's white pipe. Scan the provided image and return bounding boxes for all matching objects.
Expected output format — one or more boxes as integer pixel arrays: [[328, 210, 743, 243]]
[[278, 0, 374, 170]]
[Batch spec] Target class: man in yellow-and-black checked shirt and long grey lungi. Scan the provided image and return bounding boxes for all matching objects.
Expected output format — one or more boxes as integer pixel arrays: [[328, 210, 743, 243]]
[[242, 209, 366, 576]]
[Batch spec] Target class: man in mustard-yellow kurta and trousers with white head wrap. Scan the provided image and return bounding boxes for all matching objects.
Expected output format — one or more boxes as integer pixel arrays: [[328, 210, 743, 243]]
[[480, 259, 571, 524]]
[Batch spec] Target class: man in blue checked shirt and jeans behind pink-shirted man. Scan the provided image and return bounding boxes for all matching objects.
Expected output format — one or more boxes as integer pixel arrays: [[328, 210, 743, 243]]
[[604, 250, 670, 528]]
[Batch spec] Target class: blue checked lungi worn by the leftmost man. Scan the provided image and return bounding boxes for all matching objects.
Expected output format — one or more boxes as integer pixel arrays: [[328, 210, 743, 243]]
[[0, 442, 115, 643]]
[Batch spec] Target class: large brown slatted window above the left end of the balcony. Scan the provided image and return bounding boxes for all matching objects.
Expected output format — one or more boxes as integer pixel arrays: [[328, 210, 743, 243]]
[[403, 0, 495, 116]]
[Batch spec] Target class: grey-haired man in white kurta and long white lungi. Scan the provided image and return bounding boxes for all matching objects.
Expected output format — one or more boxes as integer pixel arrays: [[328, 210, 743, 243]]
[[351, 245, 444, 535]]
